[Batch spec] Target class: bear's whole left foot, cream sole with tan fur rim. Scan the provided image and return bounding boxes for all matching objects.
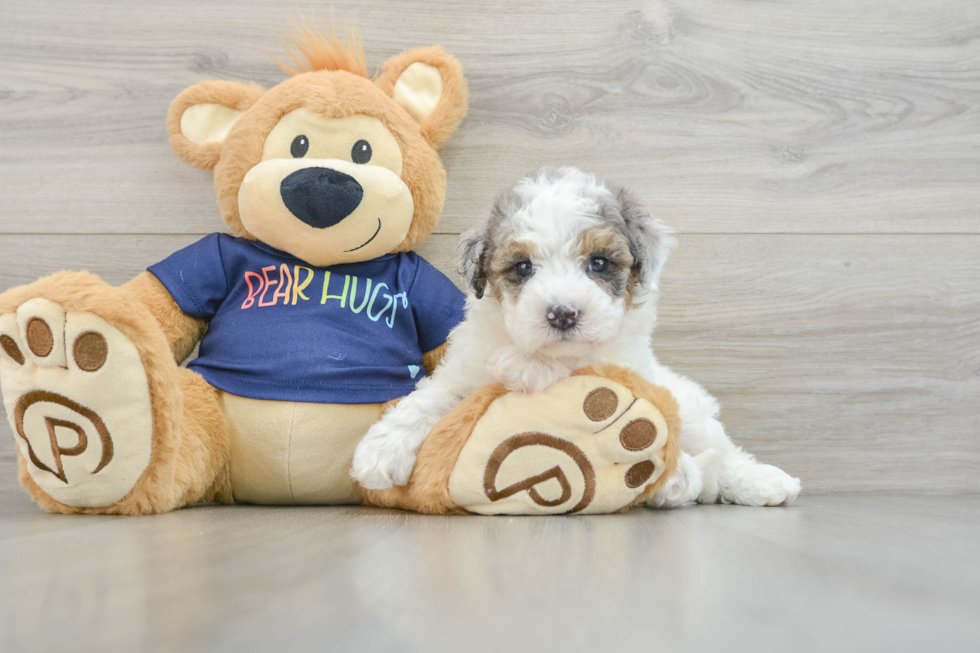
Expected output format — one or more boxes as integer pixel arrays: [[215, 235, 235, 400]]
[[0, 273, 193, 514]]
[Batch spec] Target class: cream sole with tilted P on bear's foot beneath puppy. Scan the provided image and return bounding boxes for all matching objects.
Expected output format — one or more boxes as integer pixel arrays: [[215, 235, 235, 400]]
[[449, 376, 668, 515]]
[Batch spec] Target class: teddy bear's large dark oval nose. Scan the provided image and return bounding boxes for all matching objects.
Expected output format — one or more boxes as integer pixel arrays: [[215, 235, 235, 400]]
[[279, 168, 364, 229]]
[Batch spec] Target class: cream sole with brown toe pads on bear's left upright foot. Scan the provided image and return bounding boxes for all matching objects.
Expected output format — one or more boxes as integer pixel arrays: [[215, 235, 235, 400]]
[[0, 298, 153, 507]]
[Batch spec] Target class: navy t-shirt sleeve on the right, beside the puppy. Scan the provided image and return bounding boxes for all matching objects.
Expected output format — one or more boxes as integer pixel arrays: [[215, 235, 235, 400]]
[[409, 257, 466, 352]]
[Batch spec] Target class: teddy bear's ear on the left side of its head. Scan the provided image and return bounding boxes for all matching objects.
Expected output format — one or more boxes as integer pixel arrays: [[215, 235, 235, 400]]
[[167, 81, 263, 170]]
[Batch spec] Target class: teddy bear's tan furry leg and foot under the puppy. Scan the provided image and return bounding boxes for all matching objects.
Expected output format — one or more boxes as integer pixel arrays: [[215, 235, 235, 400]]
[[365, 365, 680, 515]]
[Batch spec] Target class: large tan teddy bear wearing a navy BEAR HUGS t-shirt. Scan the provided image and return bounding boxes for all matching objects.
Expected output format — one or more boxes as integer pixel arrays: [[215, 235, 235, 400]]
[[0, 28, 679, 515]]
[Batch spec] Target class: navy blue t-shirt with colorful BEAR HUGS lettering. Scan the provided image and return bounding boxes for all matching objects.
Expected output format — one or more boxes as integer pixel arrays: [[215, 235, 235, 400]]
[[149, 234, 465, 404]]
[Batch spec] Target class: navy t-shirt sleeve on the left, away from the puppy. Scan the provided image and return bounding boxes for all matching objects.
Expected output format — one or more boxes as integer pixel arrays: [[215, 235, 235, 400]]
[[147, 234, 228, 320]]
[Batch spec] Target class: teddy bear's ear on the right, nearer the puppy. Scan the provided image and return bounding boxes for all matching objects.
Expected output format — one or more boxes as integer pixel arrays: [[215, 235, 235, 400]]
[[377, 47, 467, 149]]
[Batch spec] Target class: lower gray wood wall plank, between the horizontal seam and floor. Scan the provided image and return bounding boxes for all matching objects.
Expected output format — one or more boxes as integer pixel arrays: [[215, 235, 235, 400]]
[[0, 234, 980, 493]]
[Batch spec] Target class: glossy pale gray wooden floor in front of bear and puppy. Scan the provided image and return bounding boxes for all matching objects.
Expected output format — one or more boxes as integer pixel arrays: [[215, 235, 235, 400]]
[[0, 492, 980, 653]]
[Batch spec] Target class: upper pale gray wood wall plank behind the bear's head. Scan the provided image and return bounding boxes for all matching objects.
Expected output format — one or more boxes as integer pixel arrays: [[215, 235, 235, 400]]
[[0, 0, 980, 233]]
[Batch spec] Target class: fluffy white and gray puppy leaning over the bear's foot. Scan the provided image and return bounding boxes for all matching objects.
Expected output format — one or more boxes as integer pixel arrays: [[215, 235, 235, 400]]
[[351, 167, 800, 506]]
